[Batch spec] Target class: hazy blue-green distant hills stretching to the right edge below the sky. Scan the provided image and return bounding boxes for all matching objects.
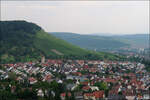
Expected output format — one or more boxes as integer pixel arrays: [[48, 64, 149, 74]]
[[51, 32, 149, 51]]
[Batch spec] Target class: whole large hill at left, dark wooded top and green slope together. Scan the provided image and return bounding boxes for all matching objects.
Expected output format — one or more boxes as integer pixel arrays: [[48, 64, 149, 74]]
[[0, 21, 124, 63]]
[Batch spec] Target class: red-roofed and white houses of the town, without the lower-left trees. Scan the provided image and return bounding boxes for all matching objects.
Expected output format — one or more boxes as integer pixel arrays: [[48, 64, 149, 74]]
[[0, 58, 150, 100]]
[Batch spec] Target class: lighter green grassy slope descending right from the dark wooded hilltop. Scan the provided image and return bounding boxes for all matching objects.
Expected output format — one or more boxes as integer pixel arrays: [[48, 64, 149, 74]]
[[34, 31, 121, 60]]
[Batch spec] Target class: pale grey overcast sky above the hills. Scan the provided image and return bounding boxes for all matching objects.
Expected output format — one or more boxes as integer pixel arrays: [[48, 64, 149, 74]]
[[1, 1, 149, 34]]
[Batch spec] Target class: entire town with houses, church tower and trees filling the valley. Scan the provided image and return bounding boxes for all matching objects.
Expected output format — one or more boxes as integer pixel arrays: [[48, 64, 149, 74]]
[[0, 56, 150, 100]]
